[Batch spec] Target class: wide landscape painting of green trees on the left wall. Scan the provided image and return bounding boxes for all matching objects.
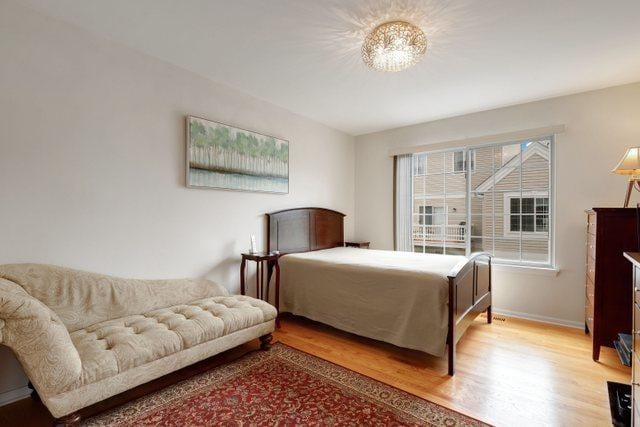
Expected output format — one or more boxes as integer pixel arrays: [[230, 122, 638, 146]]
[[187, 116, 289, 194]]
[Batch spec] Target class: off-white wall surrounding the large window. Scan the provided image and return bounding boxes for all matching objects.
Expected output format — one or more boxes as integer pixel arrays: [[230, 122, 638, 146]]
[[355, 83, 640, 326]]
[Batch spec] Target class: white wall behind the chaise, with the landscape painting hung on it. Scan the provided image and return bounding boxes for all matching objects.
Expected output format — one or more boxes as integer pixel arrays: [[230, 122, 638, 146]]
[[0, 1, 354, 402]]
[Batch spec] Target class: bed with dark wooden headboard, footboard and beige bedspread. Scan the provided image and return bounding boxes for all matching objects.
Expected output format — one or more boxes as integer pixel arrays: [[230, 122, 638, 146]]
[[267, 208, 491, 375]]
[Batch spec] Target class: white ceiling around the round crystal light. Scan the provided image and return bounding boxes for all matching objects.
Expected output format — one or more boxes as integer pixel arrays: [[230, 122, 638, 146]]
[[22, 0, 640, 135]]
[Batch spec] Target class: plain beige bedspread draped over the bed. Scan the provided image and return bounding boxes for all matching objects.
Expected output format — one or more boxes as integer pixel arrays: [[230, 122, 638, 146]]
[[280, 248, 466, 356]]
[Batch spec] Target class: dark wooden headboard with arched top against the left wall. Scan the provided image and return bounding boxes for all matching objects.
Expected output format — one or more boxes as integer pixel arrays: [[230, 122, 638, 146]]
[[267, 208, 345, 254]]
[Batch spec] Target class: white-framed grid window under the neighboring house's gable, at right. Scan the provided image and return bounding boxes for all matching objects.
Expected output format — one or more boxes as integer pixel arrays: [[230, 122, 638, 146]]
[[505, 196, 549, 234]]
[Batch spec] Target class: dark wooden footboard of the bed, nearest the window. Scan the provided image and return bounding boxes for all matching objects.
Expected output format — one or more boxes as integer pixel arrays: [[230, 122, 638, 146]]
[[447, 252, 491, 375]]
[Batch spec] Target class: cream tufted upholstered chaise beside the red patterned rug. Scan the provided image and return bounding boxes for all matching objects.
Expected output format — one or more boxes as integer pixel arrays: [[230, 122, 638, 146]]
[[0, 264, 277, 419]]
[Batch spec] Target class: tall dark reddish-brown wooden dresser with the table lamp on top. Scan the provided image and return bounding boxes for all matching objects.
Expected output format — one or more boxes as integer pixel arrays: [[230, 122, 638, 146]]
[[585, 208, 638, 360]]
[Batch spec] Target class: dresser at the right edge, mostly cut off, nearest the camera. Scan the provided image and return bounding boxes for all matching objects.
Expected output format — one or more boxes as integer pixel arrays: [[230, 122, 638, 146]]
[[624, 252, 640, 426]]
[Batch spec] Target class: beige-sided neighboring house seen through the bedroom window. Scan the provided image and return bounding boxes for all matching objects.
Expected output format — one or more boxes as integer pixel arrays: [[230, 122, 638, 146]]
[[413, 141, 550, 261]]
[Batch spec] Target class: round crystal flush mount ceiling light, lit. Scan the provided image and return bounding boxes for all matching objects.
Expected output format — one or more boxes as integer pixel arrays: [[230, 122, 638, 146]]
[[362, 21, 427, 72]]
